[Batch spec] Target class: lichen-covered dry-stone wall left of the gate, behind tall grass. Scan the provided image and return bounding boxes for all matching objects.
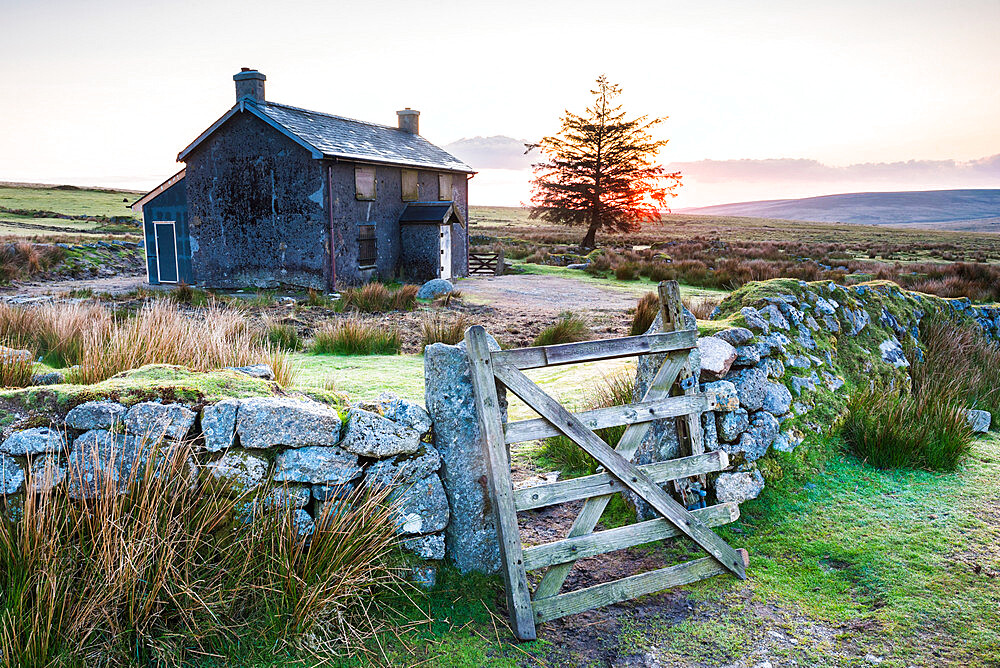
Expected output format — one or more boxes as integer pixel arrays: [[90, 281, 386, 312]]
[[0, 394, 451, 581]]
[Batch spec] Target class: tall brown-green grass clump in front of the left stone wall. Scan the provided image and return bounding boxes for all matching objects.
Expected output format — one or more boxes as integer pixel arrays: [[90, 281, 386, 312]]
[[0, 444, 400, 668]]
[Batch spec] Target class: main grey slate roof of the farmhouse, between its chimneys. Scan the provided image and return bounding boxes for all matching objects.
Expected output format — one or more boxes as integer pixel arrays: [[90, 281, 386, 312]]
[[178, 100, 474, 174]]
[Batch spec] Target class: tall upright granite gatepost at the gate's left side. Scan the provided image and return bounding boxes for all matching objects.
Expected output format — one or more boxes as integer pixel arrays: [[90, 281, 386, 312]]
[[424, 339, 507, 573]]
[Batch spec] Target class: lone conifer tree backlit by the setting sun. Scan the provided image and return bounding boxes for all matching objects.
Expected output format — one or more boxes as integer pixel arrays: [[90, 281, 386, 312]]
[[529, 75, 681, 248]]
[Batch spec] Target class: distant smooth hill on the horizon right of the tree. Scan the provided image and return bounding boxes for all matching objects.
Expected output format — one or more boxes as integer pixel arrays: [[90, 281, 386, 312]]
[[678, 190, 1000, 232]]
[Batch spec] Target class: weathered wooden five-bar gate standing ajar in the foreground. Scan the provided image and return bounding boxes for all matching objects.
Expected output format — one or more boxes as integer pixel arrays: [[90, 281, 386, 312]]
[[465, 281, 749, 640]]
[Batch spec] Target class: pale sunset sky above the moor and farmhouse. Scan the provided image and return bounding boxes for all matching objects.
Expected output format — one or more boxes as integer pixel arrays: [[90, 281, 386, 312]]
[[0, 0, 1000, 207]]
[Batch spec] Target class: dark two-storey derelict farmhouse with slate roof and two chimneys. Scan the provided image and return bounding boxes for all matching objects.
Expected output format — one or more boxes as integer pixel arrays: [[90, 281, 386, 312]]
[[132, 68, 475, 290]]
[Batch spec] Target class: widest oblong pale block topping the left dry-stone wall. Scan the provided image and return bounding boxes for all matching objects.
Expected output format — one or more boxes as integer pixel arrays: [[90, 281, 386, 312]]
[[236, 397, 341, 449]]
